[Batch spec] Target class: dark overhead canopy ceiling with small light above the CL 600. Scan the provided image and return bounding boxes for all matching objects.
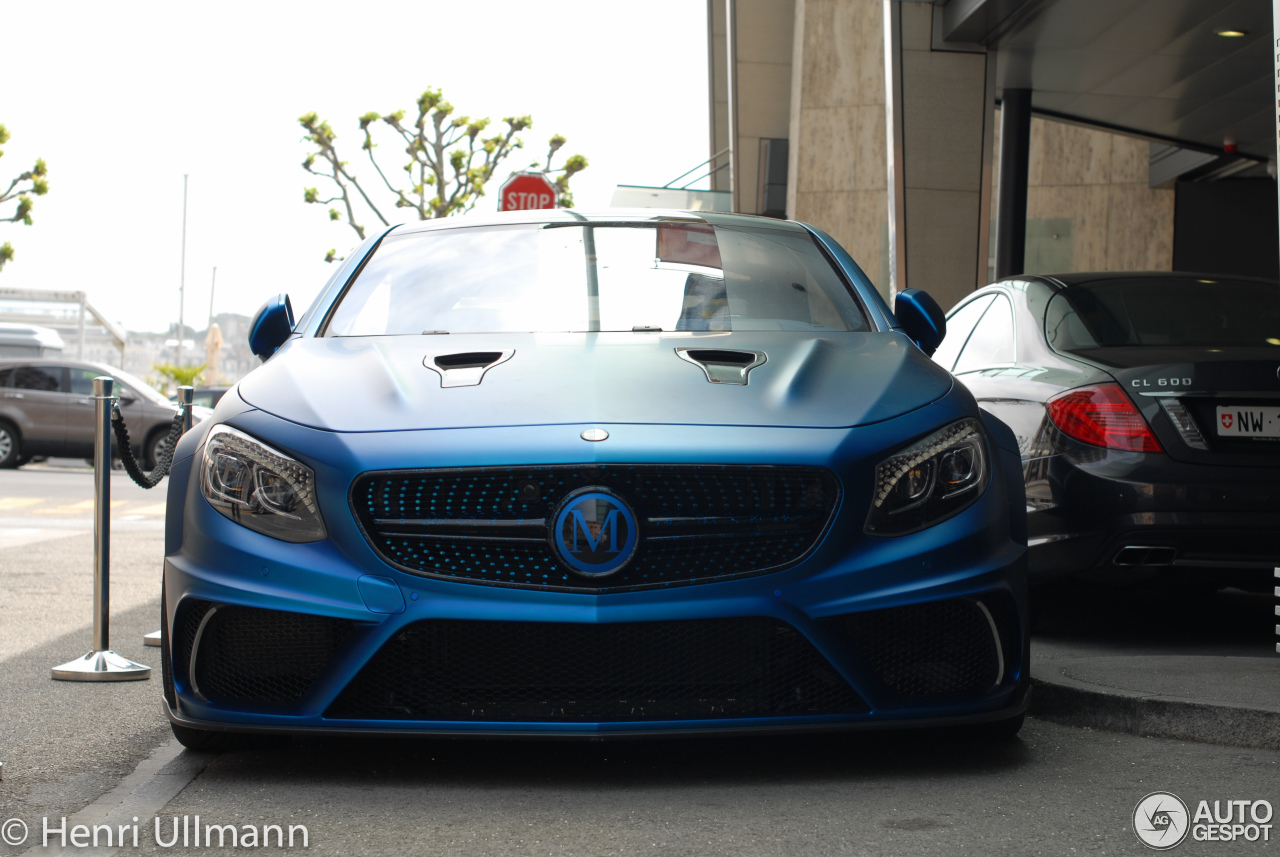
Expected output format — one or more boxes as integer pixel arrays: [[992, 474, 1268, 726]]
[[934, 0, 1276, 160]]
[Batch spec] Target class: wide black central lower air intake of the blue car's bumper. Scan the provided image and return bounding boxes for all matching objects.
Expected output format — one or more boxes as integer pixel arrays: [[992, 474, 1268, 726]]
[[325, 618, 867, 723]]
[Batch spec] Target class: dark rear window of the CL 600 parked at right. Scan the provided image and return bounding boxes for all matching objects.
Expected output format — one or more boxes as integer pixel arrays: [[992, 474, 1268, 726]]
[[1044, 278, 1280, 352]]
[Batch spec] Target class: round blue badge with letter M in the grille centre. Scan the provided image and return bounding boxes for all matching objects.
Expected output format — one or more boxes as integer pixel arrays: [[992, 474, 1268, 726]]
[[550, 487, 636, 577]]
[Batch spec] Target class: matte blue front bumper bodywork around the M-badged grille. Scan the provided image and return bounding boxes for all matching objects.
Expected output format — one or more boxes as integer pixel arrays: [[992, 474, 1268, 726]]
[[164, 402, 1029, 737]]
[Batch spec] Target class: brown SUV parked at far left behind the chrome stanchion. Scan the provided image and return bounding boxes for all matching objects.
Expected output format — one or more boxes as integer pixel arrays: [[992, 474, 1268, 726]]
[[0, 358, 189, 468]]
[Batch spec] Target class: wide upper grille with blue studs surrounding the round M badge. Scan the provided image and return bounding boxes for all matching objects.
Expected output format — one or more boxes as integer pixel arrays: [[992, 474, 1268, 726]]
[[351, 464, 840, 594]]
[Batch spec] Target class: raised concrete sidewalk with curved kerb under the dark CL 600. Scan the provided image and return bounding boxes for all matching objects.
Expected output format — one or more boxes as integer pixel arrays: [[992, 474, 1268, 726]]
[[1030, 590, 1280, 750]]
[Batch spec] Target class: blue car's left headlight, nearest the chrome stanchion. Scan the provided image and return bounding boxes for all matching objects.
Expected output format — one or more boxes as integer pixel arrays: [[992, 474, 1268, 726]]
[[200, 426, 325, 542]]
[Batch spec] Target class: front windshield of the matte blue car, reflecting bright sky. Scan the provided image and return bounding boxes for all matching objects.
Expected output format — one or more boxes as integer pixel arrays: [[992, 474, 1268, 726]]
[[325, 221, 870, 336]]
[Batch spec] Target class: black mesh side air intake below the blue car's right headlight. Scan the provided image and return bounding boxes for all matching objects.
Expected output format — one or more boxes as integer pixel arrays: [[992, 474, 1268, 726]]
[[831, 594, 1020, 700]]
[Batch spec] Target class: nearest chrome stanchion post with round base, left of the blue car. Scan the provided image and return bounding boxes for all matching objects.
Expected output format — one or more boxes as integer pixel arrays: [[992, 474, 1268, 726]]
[[52, 376, 151, 682]]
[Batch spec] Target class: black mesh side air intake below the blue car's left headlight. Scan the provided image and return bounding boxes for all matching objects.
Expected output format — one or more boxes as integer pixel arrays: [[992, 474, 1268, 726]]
[[175, 599, 355, 704]]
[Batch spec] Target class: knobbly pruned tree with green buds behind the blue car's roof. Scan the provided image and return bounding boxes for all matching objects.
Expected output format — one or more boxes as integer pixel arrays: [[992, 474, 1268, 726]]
[[298, 90, 588, 262]]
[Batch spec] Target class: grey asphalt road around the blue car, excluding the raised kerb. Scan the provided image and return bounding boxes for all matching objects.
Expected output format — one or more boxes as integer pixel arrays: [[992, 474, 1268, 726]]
[[0, 467, 1280, 857]]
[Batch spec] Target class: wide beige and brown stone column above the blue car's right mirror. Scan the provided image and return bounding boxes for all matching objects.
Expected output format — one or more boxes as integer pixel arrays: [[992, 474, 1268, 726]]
[[787, 0, 995, 307]]
